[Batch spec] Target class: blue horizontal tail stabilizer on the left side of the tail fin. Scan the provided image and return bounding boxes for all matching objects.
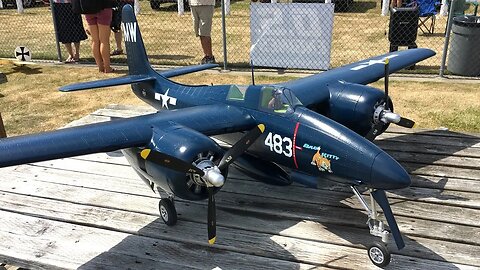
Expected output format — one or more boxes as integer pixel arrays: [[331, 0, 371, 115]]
[[60, 75, 156, 92]]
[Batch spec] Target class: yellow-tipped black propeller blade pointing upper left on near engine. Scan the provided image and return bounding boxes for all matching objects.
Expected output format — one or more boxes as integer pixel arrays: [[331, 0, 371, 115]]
[[140, 149, 205, 176]]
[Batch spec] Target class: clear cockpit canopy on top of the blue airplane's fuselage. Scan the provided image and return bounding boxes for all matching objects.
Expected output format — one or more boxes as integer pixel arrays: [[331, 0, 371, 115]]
[[260, 85, 302, 113]]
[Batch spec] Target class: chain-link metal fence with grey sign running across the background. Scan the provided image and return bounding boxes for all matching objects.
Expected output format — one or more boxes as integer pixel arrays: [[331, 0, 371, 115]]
[[0, 0, 480, 76]]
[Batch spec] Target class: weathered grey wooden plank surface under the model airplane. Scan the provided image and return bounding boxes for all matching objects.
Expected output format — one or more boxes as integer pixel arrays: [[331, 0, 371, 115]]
[[0, 105, 480, 269]]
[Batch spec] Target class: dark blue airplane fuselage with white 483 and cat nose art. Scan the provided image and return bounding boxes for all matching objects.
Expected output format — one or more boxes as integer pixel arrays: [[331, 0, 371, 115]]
[[132, 79, 410, 189]]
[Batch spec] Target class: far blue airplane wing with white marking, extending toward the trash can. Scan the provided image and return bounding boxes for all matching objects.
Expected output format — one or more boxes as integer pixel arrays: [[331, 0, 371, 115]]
[[280, 49, 435, 105]]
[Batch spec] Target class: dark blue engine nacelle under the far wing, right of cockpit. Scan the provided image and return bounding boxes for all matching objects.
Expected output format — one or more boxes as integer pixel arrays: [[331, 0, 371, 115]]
[[309, 82, 393, 136]]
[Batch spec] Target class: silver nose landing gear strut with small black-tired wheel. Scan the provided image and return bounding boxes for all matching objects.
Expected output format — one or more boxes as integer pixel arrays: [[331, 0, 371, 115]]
[[351, 186, 391, 267]]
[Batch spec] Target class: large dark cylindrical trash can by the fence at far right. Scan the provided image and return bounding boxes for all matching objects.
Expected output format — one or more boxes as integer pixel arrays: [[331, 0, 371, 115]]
[[447, 16, 480, 76]]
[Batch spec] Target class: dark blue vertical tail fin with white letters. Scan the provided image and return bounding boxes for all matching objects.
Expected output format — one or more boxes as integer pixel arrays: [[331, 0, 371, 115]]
[[122, 5, 154, 75]]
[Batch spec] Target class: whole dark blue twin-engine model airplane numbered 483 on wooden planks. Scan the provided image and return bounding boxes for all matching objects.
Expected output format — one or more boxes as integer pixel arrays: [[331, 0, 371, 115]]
[[0, 5, 434, 266]]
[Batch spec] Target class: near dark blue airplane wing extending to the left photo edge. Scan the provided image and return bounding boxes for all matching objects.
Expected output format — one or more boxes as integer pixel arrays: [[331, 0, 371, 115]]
[[0, 104, 256, 167]]
